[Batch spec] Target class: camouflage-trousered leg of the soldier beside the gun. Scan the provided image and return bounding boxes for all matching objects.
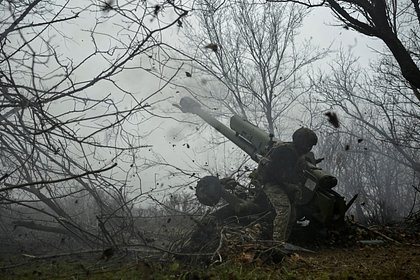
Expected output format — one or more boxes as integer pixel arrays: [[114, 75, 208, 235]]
[[264, 185, 295, 241]]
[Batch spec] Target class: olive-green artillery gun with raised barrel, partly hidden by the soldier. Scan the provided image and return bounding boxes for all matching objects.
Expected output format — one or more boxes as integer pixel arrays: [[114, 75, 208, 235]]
[[176, 97, 357, 236]]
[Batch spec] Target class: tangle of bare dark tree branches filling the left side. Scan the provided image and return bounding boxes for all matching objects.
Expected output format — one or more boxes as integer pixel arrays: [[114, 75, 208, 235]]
[[0, 0, 188, 249]]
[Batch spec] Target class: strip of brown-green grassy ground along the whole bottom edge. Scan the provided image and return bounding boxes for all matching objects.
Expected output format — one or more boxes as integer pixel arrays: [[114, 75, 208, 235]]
[[0, 243, 420, 280]]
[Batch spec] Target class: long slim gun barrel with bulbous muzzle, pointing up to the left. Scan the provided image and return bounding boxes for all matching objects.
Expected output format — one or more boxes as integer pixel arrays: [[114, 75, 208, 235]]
[[179, 97, 258, 162]]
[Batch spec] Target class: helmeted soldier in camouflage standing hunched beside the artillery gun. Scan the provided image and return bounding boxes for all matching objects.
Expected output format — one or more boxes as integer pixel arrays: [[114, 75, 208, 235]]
[[257, 127, 318, 241]]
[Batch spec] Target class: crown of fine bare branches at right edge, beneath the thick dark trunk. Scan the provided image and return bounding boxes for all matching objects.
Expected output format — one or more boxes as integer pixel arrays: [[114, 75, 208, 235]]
[[316, 49, 420, 173]]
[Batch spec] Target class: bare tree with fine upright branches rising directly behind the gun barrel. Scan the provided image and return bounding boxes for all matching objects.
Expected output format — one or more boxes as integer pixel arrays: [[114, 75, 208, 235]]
[[170, 0, 325, 134]]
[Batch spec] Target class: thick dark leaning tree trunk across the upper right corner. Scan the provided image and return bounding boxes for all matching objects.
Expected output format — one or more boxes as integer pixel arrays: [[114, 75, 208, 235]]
[[269, 0, 420, 102]]
